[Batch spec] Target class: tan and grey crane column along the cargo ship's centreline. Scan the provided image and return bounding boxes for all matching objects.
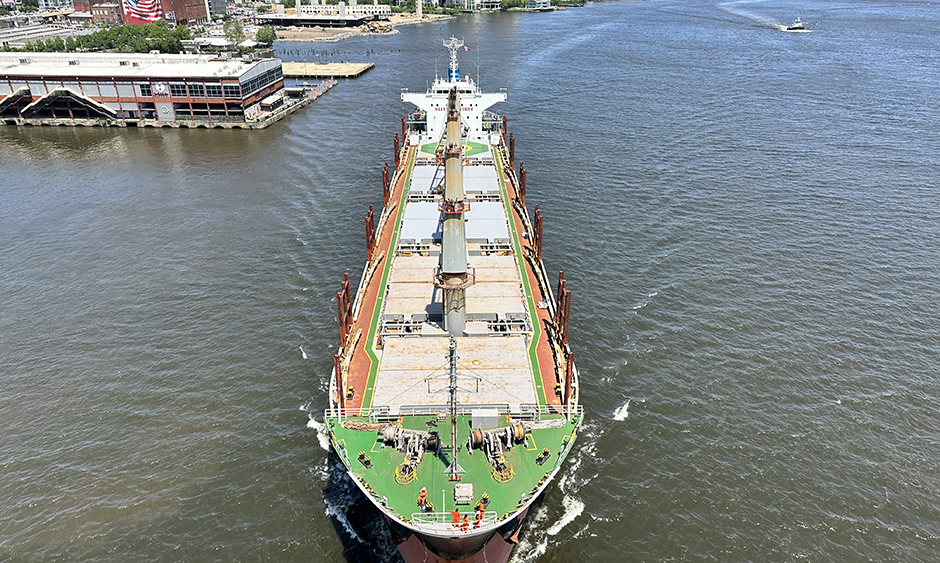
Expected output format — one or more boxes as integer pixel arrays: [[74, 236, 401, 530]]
[[437, 88, 473, 336]]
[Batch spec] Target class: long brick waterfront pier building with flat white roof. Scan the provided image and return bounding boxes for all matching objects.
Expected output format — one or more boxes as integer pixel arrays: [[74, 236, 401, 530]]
[[0, 52, 284, 127]]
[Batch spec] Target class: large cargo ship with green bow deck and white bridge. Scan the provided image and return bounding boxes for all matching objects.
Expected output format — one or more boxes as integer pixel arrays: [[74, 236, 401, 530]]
[[324, 37, 583, 563]]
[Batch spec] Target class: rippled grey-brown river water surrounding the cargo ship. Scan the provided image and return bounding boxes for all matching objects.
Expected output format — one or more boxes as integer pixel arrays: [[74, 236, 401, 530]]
[[0, 0, 940, 563]]
